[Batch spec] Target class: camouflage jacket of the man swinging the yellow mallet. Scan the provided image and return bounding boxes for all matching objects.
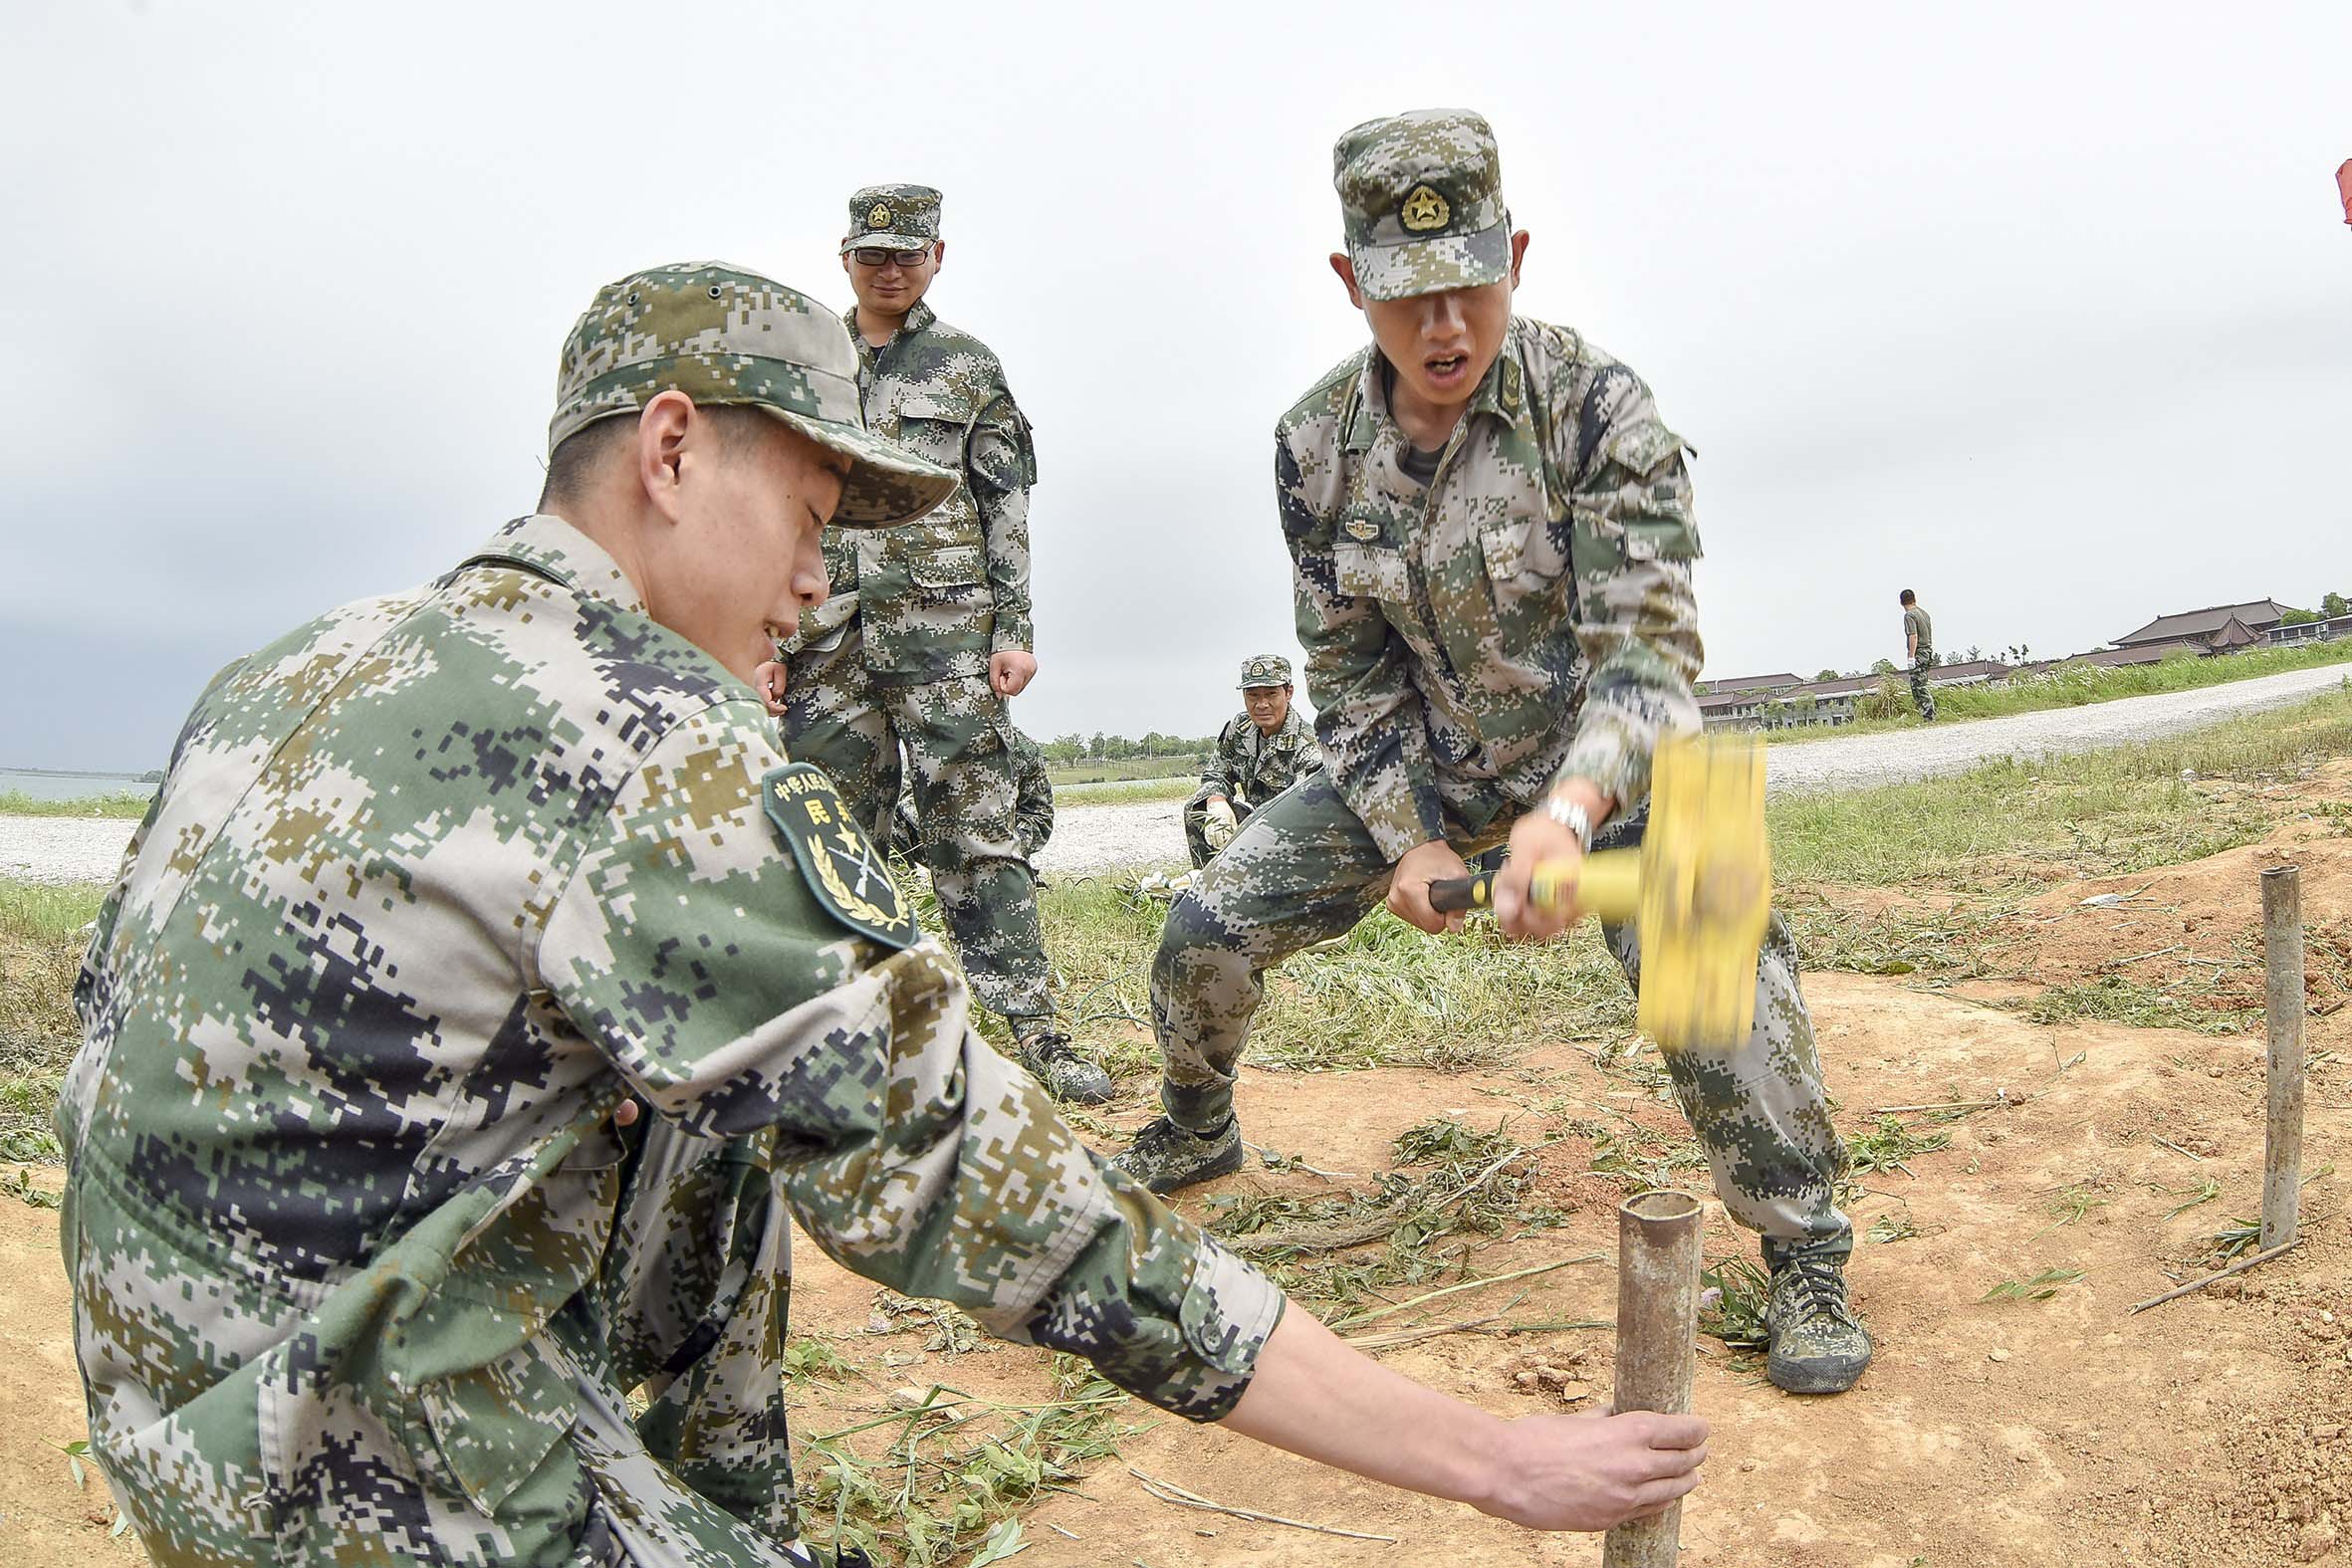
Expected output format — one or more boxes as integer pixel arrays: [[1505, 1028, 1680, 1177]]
[[1275, 318, 1701, 860]]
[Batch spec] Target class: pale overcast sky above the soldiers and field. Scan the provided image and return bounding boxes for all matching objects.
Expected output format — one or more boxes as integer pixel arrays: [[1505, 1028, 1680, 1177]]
[[0, 0, 2352, 769]]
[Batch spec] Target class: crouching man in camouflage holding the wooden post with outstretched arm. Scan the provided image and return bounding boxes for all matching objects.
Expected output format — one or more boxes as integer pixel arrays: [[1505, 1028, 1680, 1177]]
[[57, 266, 1705, 1568]]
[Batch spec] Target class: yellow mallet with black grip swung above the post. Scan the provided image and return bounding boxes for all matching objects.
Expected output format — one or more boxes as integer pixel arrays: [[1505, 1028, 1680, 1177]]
[[1430, 736, 1771, 1048]]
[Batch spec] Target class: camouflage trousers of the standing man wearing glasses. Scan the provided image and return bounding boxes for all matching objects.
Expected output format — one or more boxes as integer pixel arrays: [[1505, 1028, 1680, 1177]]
[[784, 620, 1054, 1032]]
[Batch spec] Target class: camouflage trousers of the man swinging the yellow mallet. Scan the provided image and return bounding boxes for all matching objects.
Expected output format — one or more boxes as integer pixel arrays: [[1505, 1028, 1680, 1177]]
[[1152, 774, 1853, 1257]]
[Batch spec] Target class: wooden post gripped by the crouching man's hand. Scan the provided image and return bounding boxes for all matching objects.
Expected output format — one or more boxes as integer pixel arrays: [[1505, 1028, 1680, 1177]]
[[1602, 1190, 1705, 1568]]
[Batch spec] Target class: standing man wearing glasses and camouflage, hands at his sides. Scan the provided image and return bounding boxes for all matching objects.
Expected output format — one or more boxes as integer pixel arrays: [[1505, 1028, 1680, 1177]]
[[762, 186, 1110, 1102]]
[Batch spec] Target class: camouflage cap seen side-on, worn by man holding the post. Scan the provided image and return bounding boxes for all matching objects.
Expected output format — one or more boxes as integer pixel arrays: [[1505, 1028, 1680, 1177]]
[[548, 261, 957, 527]]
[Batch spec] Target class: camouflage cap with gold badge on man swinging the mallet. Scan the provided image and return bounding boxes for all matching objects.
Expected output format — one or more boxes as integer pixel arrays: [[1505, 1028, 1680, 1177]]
[[1331, 109, 1510, 299]]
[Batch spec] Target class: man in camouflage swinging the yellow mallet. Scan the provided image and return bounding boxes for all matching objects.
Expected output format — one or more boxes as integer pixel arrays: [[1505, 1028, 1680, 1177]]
[[1117, 111, 1870, 1392]]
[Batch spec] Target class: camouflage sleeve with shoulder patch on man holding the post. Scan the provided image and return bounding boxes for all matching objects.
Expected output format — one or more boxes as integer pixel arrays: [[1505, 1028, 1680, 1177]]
[[539, 698, 1285, 1420]]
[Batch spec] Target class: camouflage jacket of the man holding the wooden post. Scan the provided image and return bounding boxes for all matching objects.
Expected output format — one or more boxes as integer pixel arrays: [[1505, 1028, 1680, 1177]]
[[57, 515, 1282, 1568]]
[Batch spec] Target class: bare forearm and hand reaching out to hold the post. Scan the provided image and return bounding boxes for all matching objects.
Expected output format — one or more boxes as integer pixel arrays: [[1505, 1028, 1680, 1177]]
[[1223, 1312, 1708, 1530]]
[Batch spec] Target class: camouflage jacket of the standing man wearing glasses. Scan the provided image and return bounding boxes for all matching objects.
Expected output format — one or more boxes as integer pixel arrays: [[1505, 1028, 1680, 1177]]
[[786, 301, 1038, 684]]
